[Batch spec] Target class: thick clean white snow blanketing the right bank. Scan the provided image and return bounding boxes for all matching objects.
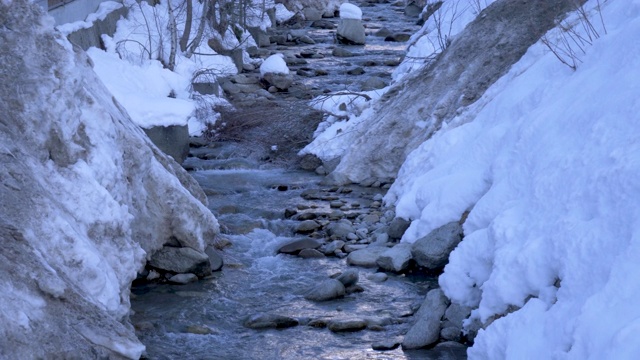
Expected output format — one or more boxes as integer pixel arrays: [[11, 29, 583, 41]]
[[386, 1, 640, 359]]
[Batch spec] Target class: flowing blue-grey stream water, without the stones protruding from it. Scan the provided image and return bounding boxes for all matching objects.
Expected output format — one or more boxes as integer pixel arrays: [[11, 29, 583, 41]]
[[132, 2, 464, 360]]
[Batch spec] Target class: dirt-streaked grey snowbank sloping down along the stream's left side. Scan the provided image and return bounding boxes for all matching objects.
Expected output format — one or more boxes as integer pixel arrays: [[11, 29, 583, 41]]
[[0, 0, 218, 359]]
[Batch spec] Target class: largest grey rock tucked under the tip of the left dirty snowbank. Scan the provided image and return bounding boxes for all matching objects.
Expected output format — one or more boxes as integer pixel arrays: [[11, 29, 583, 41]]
[[149, 246, 211, 277]]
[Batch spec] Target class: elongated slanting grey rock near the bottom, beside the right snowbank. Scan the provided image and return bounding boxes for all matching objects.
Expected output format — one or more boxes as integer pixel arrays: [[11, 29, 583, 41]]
[[402, 289, 447, 349]]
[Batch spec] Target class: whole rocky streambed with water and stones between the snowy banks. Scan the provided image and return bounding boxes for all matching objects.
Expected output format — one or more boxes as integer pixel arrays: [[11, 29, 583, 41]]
[[131, 1, 467, 360]]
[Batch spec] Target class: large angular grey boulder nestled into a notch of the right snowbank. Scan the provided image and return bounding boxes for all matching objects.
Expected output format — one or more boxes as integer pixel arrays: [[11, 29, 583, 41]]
[[411, 221, 463, 269]]
